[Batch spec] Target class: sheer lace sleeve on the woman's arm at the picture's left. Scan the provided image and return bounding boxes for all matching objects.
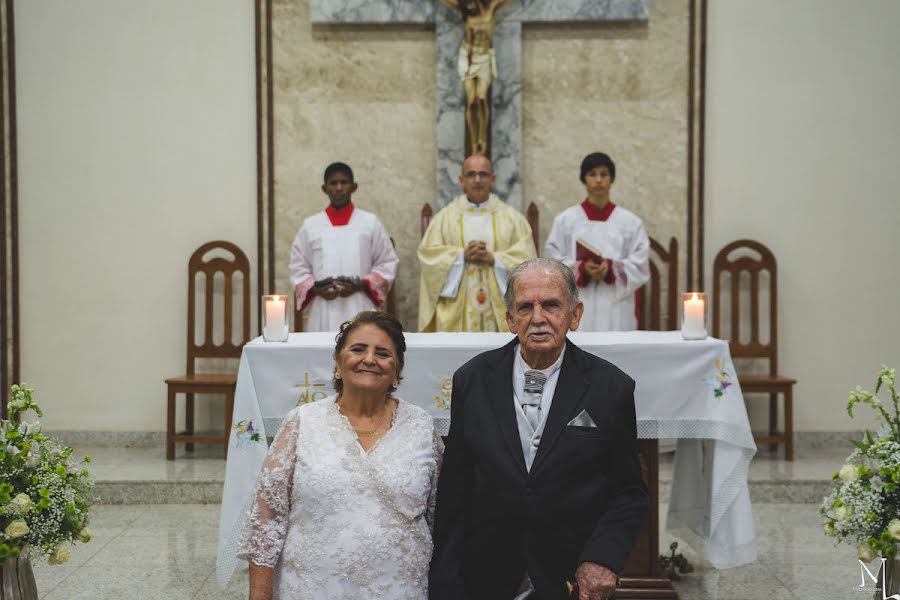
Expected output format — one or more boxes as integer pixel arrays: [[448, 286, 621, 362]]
[[238, 409, 299, 568]]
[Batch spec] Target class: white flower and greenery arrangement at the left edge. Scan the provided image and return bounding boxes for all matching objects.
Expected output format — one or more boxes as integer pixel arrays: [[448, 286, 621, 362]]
[[0, 383, 94, 564]]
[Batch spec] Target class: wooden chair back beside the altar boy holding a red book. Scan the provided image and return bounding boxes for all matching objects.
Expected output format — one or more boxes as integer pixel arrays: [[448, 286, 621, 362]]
[[637, 237, 678, 331]]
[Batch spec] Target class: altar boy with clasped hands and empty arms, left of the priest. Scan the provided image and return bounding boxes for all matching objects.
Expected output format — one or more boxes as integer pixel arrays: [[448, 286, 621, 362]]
[[289, 162, 398, 331]]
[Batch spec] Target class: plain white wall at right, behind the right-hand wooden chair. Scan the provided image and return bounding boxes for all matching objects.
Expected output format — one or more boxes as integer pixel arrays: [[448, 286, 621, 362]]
[[705, 0, 900, 430]]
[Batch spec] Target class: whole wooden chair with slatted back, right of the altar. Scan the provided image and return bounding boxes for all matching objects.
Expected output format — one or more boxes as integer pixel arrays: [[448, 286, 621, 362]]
[[712, 240, 797, 460]]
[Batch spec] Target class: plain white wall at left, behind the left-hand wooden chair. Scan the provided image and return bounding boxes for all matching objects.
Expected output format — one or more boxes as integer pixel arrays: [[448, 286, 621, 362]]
[[15, 0, 256, 431]]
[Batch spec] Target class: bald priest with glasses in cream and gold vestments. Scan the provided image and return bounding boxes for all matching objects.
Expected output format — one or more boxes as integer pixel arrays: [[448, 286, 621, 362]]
[[418, 154, 536, 331]]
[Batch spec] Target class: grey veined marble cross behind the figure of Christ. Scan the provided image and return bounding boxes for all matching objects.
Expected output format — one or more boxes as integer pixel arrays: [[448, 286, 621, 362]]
[[310, 0, 650, 210]]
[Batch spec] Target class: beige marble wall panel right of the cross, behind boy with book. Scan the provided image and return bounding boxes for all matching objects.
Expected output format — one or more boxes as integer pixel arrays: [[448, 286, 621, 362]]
[[522, 0, 689, 272]]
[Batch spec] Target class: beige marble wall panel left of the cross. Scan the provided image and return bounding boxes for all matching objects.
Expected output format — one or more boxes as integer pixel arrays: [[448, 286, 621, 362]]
[[273, 0, 437, 327]]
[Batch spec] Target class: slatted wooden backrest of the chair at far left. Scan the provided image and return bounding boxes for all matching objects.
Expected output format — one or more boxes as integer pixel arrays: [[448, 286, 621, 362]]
[[187, 240, 250, 375]]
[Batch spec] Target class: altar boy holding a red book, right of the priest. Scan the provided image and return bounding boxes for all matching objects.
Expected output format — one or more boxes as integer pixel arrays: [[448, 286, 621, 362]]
[[544, 152, 650, 331]]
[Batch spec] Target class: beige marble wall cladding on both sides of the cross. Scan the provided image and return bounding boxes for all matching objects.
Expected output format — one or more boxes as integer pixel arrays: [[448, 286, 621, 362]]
[[273, 0, 688, 328]]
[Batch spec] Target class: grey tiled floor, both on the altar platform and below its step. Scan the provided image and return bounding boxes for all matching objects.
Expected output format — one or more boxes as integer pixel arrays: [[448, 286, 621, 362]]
[[35, 445, 871, 600]]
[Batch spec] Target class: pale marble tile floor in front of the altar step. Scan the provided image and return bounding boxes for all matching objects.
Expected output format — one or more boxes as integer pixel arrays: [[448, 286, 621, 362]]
[[29, 503, 872, 600]]
